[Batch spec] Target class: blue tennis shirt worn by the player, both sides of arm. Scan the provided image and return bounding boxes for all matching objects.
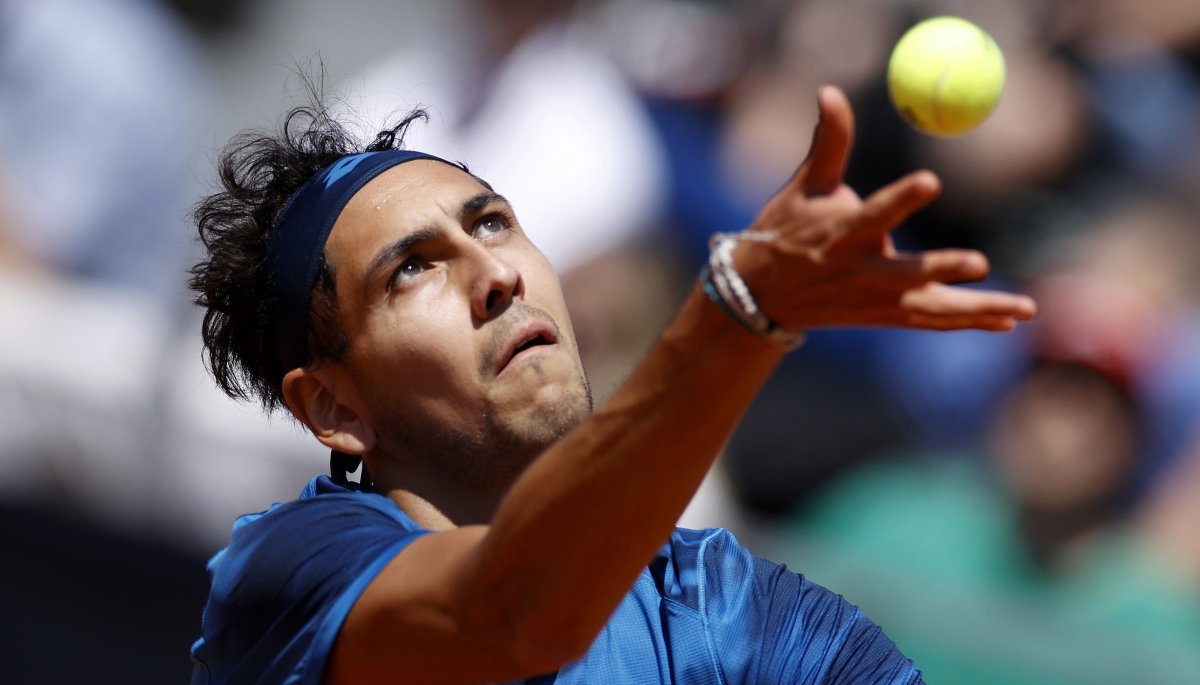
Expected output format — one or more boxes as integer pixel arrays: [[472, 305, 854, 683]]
[[192, 476, 922, 685]]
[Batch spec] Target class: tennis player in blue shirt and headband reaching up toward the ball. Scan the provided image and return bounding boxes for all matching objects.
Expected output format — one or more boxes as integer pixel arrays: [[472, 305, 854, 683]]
[[192, 86, 1034, 685]]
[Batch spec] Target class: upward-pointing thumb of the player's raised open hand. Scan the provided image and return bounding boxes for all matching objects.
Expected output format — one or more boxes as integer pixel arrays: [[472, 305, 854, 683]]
[[796, 85, 854, 197]]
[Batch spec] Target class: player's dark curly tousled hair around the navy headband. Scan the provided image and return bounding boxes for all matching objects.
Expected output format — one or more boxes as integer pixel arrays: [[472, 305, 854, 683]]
[[188, 90, 468, 411]]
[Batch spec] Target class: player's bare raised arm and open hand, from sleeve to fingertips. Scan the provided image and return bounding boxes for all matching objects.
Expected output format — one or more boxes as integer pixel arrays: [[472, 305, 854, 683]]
[[328, 88, 1033, 684]]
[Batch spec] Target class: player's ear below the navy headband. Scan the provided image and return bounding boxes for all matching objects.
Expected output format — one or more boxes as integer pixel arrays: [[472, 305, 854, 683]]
[[283, 365, 376, 455]]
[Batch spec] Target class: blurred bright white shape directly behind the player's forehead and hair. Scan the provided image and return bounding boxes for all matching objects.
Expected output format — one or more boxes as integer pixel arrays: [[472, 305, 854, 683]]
[[348, 15, 665, 272]]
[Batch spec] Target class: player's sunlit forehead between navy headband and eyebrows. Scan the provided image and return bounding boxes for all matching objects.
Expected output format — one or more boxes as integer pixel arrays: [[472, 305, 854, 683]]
[[325, 160, 487, 272]]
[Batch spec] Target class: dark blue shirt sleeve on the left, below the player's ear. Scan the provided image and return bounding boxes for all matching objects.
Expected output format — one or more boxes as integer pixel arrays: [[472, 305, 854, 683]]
[[192, 494, 425, 685]]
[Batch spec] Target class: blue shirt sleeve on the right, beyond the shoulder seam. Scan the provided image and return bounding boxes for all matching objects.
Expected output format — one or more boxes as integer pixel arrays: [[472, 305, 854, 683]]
[[672, 530, 923, 685]]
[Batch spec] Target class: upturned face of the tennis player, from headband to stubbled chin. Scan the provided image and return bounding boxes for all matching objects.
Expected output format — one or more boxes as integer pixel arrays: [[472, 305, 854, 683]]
[[326, 161, 592, 483]]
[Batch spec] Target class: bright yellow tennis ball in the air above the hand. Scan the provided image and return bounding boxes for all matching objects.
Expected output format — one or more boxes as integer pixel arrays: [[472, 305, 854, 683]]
[[888, 17, 1004, 137]]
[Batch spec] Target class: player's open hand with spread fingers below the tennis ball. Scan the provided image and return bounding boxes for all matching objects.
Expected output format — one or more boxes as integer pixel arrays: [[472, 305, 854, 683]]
[[733, 86, 1037, 331]]
